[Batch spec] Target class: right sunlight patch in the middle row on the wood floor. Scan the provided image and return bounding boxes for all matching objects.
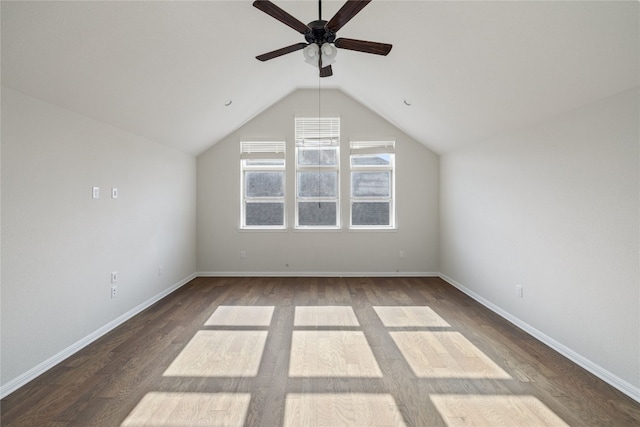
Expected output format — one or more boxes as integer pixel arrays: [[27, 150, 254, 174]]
[[390, 331, 511, 379]]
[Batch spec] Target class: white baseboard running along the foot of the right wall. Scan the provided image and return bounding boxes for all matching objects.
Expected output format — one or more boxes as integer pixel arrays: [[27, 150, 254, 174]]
[[440, 274, 640, 402]]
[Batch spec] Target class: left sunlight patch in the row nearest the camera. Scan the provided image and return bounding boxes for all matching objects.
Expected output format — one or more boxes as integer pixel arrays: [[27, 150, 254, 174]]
[[121, 392, 251, 427]]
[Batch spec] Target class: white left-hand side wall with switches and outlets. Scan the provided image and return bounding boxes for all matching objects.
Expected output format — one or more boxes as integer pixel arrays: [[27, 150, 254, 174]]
[[1, 88, 196, 393]]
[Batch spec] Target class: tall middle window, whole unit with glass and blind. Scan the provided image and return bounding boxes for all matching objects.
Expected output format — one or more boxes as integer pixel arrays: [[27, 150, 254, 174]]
[[295, 117, 340, 228]]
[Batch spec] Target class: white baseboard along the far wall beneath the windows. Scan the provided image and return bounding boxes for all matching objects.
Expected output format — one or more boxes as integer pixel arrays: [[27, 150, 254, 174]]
[[197, 271, 440, 277]]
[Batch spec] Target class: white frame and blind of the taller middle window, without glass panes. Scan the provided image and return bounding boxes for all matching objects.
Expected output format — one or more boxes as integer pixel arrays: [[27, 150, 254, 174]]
[[295, 117, 341, 230]]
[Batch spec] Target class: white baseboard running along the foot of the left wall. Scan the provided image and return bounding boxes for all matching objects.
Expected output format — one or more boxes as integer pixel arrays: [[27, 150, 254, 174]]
[[0, 274, 197, 399]]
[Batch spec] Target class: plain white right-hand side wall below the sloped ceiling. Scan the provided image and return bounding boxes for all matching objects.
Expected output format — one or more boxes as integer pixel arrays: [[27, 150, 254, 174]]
[[441, 88, 640, 399]]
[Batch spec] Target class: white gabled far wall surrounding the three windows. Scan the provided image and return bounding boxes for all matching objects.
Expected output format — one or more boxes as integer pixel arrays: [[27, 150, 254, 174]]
[[197, 89, 439, 275]]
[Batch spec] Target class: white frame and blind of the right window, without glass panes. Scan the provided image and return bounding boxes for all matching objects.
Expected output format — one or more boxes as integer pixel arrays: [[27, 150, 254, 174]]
[[349, 140, 396, 230]]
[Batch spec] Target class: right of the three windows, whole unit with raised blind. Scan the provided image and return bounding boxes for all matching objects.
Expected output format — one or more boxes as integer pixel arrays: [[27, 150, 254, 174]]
[[350, 141, 395, 228]]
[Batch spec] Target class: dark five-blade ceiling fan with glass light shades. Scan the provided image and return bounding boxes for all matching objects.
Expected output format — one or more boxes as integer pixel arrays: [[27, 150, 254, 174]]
[[253, 0, 392, 77]]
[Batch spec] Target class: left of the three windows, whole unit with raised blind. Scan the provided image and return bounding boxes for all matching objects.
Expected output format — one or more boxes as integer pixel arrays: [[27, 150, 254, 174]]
[[240, 141, 285, 228]]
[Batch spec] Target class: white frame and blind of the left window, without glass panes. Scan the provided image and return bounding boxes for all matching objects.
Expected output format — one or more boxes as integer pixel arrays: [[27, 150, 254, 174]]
[[240, 141, 287, 230]]
